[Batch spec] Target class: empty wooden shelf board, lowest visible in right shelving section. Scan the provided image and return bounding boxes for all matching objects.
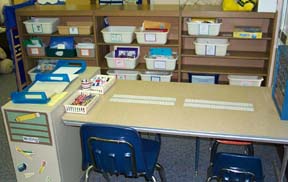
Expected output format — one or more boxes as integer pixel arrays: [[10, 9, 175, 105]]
[[181, 65, 267, 76]]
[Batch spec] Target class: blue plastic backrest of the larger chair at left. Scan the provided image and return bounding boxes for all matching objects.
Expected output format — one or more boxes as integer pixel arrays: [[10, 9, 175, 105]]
[[80, 124, 147, 177]]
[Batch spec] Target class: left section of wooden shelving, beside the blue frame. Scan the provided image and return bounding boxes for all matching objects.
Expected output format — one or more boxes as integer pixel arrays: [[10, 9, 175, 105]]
[[16, 5, 98, 90]]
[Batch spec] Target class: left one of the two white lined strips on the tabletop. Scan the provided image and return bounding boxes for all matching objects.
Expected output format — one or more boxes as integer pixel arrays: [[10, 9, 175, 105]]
[[110, 94, 176, 106]]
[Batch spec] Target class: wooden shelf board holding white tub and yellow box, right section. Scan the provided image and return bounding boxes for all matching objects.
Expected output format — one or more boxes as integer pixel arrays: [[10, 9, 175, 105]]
[[181, 31, 272, 40]]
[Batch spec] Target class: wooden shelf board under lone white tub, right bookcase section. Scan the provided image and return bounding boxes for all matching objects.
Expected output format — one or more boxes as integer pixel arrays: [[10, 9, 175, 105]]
[[181, 49, 269, 60]]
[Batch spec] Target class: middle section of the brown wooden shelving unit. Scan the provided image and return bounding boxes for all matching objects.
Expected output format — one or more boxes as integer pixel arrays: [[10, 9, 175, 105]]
[[95, 5, 180, 81]]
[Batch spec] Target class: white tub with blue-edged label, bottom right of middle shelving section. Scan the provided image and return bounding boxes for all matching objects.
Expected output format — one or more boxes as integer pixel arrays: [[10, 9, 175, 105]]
[[140, 71, 172, 82]]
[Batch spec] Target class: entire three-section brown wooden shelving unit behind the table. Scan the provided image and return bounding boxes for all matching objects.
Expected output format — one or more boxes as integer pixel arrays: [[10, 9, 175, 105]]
[[16, 5, 277, 88]]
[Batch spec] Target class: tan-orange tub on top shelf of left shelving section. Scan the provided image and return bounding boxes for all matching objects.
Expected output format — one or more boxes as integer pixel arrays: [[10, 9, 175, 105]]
[[57, 22, 92, 35]]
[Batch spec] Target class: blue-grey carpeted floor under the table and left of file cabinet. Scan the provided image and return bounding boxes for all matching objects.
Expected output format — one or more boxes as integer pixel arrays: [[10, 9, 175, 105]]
[[0, 74, 280, 182]]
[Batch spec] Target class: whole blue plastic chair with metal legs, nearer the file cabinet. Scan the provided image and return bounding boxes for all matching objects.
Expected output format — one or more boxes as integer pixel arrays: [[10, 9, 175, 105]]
[[80, 124, 166, 181]]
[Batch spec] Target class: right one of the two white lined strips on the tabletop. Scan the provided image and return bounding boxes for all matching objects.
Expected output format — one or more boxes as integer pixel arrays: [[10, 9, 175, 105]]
[[184, 99, 254, 112]]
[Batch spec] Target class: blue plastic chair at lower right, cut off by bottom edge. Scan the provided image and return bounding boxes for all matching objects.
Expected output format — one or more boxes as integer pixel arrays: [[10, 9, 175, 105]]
[[207, 152, 264, 182]]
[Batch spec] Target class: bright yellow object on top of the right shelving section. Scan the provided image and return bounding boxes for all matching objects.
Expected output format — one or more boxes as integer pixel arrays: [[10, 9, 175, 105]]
[[222, 0, 257, 11]]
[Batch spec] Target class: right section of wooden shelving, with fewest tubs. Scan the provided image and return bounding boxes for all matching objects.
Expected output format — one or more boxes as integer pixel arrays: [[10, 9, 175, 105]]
[[179, 6, 277, 86]]
